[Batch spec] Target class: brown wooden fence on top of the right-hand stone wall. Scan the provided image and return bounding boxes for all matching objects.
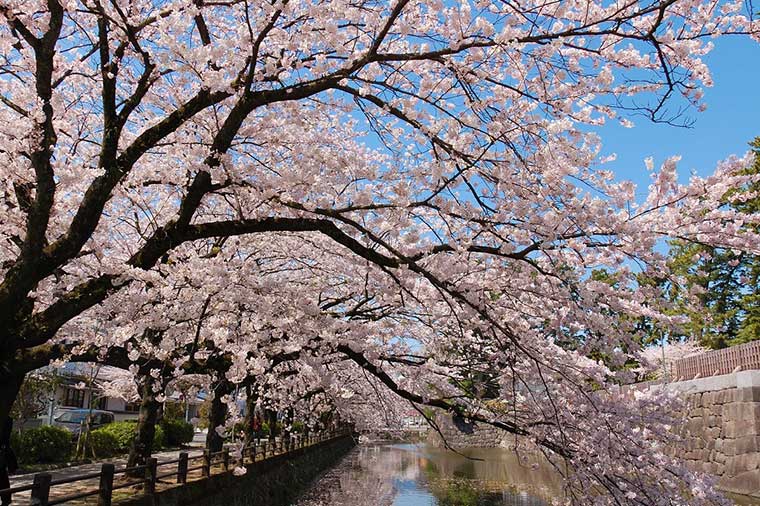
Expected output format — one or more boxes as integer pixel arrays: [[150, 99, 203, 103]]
[[671, 341, 760, 380]]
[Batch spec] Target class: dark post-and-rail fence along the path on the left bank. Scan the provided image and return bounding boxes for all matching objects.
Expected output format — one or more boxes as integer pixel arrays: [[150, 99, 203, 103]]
[[0, 430, 348, 506]]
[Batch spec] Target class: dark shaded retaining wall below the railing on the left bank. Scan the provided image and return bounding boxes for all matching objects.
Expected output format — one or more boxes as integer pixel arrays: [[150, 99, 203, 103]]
[[115, 436, 355, 506]]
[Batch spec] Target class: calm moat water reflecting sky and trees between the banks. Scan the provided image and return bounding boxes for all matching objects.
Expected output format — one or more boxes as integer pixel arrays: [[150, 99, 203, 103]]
[[297, 445, 561, 506]]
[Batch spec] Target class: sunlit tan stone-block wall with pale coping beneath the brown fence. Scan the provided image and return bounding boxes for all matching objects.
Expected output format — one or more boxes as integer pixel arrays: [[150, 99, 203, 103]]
[[666, 371, 760, 497]]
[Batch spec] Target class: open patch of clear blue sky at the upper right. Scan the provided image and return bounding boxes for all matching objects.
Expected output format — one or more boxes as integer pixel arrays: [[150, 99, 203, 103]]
[[599, 37, 760, 196]]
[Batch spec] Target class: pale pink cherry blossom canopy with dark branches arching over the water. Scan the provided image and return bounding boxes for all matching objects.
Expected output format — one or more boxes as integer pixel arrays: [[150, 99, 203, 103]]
[[0, 0, 760, 505]]
